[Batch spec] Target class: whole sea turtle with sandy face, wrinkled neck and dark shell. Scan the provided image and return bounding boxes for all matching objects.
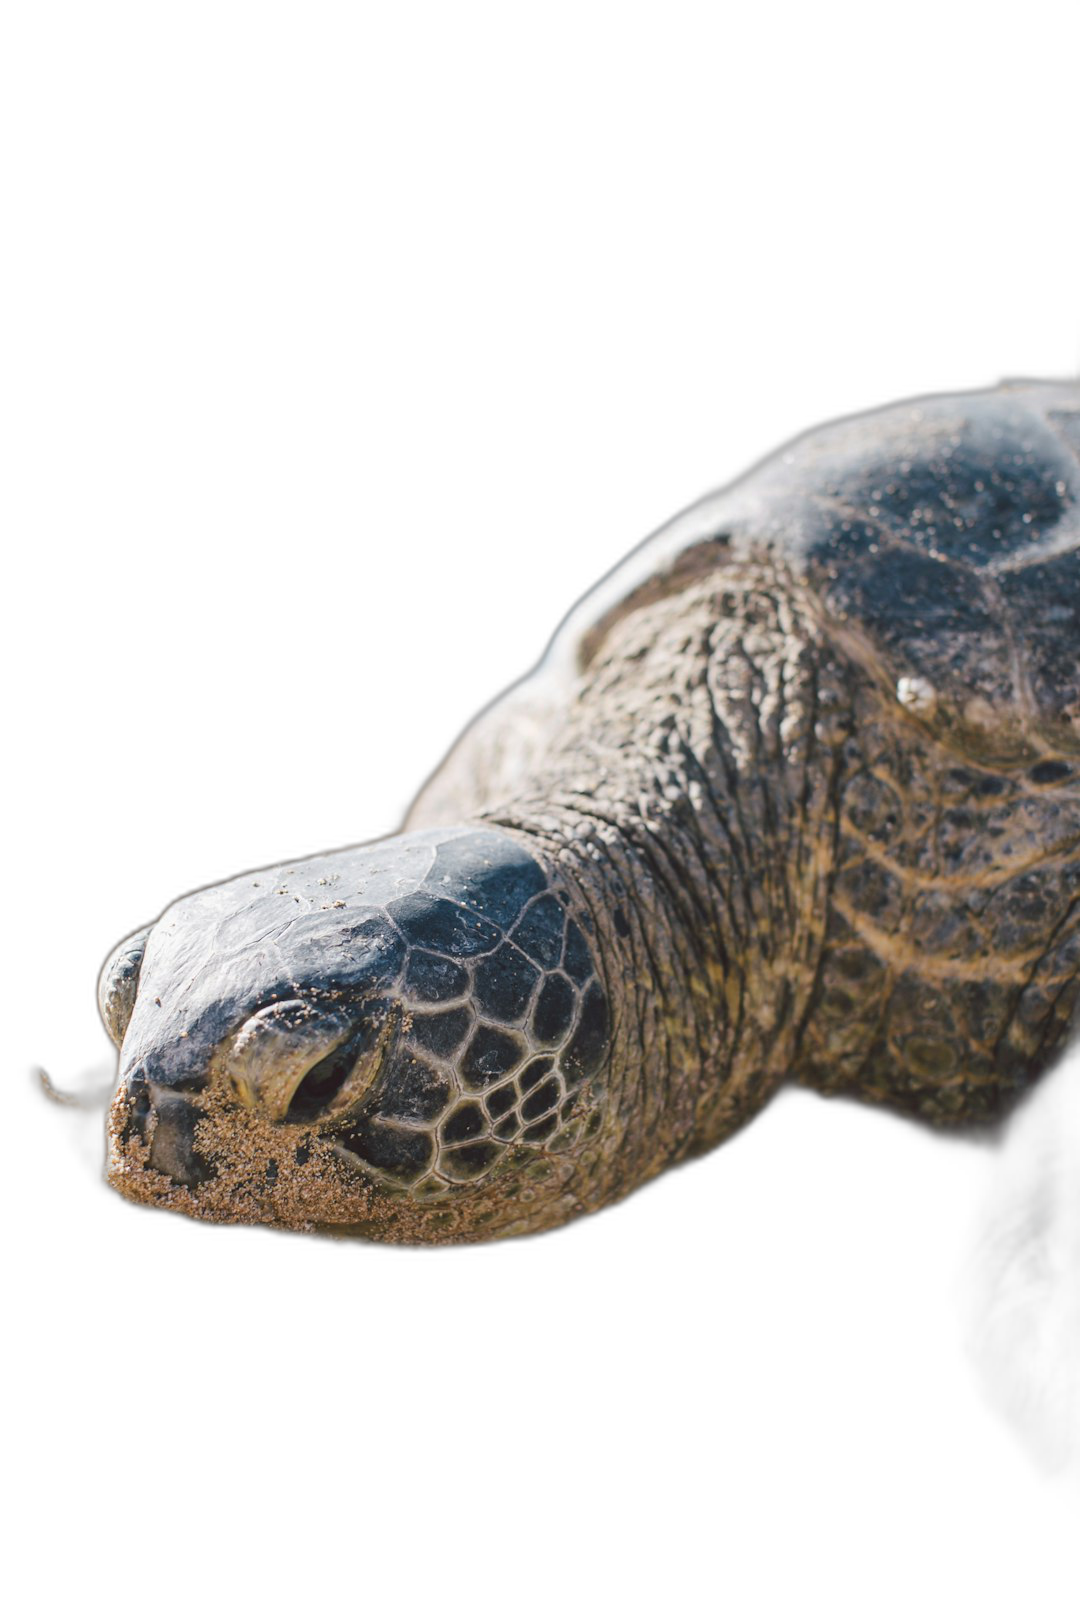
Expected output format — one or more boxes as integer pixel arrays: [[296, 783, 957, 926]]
[[88, 382, 1080, 1247]]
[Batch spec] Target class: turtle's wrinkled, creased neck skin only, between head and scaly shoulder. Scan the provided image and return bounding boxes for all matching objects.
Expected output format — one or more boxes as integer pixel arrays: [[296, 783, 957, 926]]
[[408, 573, 850, 1209]]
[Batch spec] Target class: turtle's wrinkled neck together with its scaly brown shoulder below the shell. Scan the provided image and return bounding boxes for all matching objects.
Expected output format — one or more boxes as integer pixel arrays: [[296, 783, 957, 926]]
[[411, 557, 1080, 1200]]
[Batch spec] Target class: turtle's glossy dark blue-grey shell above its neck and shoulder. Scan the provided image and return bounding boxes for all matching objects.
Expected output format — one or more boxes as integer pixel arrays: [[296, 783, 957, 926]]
[[552, 384, 1080, 765]]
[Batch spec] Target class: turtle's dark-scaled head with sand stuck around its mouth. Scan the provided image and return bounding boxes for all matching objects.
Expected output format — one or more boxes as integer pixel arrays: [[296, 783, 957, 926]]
[[99, 826, 610, 1246]]
